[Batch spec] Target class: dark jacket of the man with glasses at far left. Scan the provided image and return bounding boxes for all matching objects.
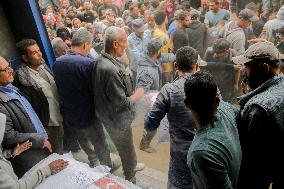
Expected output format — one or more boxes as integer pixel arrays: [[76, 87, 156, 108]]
[[0, 88, 48, 177]]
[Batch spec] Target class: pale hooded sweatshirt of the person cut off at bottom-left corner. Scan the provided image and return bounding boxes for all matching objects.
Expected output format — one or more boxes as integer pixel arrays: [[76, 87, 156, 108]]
[[0, 113, 51, 189]]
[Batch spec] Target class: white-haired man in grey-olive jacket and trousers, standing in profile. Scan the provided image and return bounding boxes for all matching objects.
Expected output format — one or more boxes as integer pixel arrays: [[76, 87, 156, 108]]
[[92, 26, 144, 183]]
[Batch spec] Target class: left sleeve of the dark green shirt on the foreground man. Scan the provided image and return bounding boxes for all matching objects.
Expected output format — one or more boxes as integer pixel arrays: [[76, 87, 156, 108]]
[[190, 151, 233, 189]]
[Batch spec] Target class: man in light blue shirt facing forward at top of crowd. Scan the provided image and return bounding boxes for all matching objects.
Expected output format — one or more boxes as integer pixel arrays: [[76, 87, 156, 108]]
[[204, 0, 230, 27]]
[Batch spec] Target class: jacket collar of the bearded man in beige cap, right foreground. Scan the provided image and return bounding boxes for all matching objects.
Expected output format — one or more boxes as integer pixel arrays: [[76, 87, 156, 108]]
[[237, 74, 284, 107]]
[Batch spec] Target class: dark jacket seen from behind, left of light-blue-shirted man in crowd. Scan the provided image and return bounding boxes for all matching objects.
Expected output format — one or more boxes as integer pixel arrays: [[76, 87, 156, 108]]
[[185, 20, 207, 57]]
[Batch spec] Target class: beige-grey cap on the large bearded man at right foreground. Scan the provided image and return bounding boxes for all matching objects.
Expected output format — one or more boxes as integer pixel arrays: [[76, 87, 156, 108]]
[[232, 42, 283, 64]]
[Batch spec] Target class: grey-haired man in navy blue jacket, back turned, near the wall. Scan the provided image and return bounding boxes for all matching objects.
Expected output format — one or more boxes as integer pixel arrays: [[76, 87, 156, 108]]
[[54, 28, 116, 168]]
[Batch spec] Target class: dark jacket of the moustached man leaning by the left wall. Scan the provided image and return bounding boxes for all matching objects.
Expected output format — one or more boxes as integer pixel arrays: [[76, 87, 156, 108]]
[[13, 63, 52, 127]]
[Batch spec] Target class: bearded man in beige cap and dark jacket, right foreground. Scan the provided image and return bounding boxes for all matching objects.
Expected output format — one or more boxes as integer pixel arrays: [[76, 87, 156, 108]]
[[233, 42, 284, 189]]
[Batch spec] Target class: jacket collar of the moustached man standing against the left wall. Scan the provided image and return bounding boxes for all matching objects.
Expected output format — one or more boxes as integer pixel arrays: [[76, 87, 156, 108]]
[[14, 63, 52, 89]]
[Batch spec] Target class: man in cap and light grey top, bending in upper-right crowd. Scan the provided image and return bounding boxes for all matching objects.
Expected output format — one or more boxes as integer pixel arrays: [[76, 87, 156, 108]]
[[220, 9, 258, 55]]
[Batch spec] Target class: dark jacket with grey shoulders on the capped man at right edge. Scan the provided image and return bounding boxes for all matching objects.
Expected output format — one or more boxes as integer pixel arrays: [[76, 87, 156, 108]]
[[238, 74, 284, 188]]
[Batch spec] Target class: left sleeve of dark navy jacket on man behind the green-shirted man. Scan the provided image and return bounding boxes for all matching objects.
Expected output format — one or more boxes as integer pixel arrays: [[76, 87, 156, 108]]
[[144, 84, 169, 131]]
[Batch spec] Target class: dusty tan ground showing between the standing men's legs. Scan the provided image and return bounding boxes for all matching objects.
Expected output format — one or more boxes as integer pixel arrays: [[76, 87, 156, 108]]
[[73, 108, 170, 189]]
